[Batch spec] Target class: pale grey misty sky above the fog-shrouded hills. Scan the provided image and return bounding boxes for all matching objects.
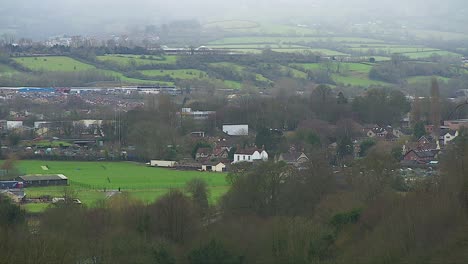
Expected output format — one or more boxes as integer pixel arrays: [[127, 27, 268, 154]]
[[0, 0, 468, 37]]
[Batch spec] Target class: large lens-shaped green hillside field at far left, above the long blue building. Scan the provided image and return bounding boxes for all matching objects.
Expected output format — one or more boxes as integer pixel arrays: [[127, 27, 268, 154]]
[[14, 56, 96, 72]]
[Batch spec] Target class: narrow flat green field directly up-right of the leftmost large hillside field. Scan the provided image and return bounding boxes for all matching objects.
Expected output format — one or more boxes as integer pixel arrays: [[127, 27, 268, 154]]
[[97, 55, 177, 66]]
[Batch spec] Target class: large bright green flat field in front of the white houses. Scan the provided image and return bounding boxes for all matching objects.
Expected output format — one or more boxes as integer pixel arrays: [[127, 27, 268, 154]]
[[17, 161, 228, 211]]
